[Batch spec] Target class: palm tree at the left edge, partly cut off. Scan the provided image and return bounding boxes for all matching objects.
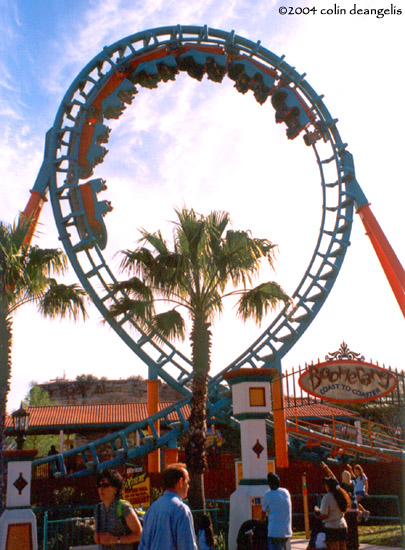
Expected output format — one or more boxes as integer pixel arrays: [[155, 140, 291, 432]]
[[0, 220, 86, 510]]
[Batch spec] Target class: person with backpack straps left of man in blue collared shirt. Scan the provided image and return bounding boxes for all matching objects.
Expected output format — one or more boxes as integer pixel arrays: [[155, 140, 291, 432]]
[[94, 470, 142, 550]]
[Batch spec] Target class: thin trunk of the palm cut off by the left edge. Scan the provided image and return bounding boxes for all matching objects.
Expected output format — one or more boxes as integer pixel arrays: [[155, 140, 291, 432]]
[[0, 303, 12, 514]]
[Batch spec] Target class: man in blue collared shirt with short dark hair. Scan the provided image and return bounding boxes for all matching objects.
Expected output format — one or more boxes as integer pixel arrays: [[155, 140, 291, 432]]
[[139, 463, 197, 550]]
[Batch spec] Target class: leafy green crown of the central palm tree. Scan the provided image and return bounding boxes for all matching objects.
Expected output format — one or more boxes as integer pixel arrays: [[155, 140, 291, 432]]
[[111, 207, 288, 330]]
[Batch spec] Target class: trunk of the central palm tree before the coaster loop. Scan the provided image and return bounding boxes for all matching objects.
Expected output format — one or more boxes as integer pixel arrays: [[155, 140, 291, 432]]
[[185, 316, 211, 511]]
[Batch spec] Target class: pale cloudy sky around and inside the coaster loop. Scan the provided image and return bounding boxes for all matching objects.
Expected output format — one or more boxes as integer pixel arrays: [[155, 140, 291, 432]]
[[0, 0, 405, 411]]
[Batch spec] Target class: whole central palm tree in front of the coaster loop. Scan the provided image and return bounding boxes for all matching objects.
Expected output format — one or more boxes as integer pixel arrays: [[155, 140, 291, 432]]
[[110, 208, 290, 510]]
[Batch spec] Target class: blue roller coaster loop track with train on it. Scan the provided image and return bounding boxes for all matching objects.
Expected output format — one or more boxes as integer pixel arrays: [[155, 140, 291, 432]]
[[30, 25, 380, 473]]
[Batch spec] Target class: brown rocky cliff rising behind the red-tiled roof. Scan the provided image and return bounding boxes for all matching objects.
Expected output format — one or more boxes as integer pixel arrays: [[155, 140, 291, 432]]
[[38, 375, 182, 405]]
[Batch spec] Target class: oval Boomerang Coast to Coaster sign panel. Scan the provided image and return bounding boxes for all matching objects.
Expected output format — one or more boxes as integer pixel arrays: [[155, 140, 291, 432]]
[[298, 360, 397, 403]]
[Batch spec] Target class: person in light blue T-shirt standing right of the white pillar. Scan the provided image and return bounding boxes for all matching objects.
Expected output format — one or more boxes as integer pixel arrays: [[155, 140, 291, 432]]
[[262, 473, 292, 550]]
